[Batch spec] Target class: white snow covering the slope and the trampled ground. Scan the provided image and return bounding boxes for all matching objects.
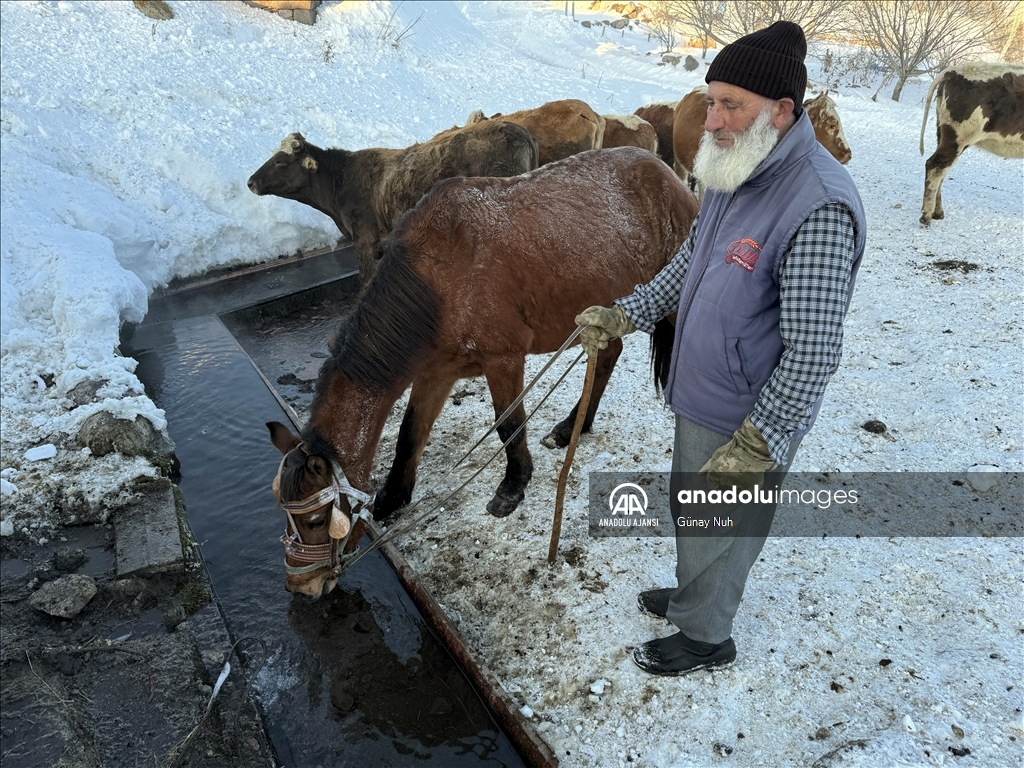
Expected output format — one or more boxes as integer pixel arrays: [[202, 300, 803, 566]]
[[0, 2, 1024, 766]]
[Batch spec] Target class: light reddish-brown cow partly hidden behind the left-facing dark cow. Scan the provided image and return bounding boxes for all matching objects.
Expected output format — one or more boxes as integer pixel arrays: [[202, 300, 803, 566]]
[[431, 98, 604, 165]]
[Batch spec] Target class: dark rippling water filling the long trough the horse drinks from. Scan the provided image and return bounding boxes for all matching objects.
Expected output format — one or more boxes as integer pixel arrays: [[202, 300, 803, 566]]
[[123, 292, 522, 768]]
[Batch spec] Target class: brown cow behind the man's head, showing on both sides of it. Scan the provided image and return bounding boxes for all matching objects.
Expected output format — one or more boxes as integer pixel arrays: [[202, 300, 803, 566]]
[[672, 85, 853, 199]]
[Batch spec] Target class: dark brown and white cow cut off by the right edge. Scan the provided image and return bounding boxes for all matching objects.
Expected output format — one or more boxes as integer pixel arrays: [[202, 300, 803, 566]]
[[921, 61, 1024, 225]]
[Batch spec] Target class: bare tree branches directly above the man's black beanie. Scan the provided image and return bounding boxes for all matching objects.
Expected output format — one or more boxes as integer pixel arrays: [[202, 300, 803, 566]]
[[713, 0, 851, 42]]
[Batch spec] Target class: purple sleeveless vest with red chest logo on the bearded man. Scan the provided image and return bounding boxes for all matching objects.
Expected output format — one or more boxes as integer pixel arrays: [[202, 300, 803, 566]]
[[666, 113, 866, 435]]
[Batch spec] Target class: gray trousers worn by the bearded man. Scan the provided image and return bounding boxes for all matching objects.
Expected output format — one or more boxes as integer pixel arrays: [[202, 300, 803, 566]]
[[668, 416, 800, 645]]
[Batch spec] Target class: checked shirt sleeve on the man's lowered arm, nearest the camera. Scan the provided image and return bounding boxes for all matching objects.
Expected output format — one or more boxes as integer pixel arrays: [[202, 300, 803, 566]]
[[749, 203, 856, 464]]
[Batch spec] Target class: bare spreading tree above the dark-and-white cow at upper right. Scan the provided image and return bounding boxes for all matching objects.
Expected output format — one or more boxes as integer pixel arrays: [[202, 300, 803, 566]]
[[853, 0, 1019, 101]]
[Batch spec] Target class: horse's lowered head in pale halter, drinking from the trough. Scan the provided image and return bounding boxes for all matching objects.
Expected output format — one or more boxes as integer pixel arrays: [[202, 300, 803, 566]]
[[266, 422, 369, 599]]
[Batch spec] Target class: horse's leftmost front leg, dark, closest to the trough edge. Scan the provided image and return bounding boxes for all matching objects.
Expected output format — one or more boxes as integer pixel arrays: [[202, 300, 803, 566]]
[[374, 378, 456, 519]]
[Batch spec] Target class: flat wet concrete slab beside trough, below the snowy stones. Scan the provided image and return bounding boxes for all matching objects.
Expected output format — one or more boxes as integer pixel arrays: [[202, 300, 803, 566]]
[[114, 477, 184, 577]]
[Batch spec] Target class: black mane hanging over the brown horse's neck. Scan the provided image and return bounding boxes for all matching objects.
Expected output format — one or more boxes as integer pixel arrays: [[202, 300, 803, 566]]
[[312, 240, 440, 413]]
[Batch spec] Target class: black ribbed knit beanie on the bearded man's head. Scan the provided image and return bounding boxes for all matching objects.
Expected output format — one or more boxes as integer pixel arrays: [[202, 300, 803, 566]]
[[705, 22, 807, 115]]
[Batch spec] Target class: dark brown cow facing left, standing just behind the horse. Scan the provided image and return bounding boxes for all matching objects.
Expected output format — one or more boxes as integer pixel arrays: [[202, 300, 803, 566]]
[[249, 120, 539, 285]]
